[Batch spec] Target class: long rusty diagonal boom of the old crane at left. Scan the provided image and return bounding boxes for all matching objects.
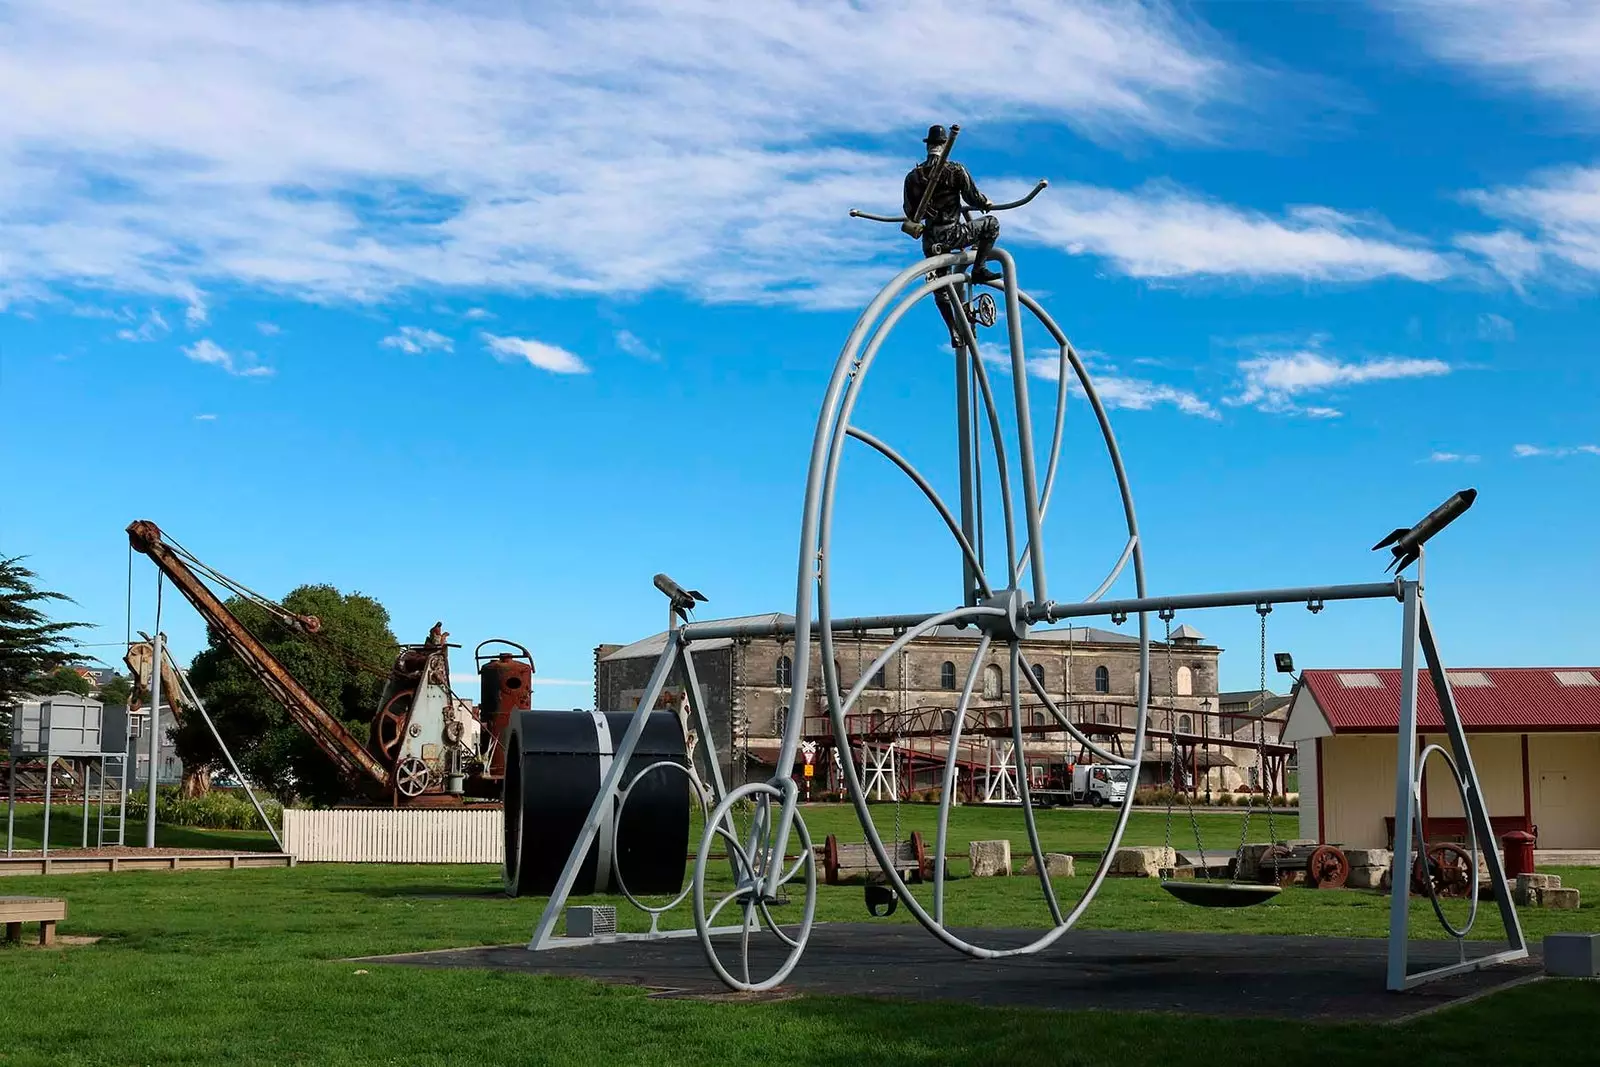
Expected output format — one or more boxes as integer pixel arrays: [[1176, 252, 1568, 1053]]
[[128, 518, 390, 792]]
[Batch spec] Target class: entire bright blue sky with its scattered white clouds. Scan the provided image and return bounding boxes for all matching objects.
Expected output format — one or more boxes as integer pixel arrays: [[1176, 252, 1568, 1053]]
[[0, 0, 1600, 707]]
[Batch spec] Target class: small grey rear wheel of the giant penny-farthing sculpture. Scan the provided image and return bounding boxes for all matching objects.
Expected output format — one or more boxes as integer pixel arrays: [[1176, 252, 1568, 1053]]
[[693, 782, 816, 992]]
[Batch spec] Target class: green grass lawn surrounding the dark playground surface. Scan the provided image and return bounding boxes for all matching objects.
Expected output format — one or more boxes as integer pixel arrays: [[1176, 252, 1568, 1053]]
[[0, 806, 1600, 1067]]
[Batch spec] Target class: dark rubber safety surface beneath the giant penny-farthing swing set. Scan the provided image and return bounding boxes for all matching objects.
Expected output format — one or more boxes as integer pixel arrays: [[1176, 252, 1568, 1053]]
[[353, 923, 1541, 1022]]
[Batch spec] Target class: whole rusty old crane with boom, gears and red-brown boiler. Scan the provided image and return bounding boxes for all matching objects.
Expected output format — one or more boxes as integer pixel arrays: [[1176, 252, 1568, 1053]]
[[128, 520, 534, 806]]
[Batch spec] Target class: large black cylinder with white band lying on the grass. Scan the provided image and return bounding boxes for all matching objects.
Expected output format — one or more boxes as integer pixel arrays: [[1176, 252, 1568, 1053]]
[[504, 712, 690, 896]]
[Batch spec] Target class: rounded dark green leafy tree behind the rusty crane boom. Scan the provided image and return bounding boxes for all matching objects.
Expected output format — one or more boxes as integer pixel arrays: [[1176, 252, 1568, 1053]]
[[173, 585, 398, 803]]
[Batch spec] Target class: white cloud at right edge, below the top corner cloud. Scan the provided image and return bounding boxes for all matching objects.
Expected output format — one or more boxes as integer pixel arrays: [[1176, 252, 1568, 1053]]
[[1456, 164, 1600, 288]]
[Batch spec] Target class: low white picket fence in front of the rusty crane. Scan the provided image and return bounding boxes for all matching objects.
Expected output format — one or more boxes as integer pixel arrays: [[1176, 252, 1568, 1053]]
[[283, 808, 506, 864]]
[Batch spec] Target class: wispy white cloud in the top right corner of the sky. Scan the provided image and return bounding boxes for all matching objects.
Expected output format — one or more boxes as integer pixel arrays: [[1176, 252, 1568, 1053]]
[[1386, 0, 1600, 107]]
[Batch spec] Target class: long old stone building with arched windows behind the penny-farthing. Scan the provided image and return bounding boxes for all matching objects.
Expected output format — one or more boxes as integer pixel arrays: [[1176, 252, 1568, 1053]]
[[595, 616, 1237, 787]]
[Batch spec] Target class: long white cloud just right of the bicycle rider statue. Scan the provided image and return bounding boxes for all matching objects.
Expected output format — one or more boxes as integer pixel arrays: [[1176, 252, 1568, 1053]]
[[1002, 184, 1458, 282]]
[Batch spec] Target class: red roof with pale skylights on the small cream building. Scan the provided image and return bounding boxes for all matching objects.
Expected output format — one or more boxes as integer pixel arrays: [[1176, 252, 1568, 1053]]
[[1283, 667, 1600, 741]]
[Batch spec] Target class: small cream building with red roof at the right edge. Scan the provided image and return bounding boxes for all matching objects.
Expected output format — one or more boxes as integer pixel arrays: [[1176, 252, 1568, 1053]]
[[1283, 667, 1600, 849]]
